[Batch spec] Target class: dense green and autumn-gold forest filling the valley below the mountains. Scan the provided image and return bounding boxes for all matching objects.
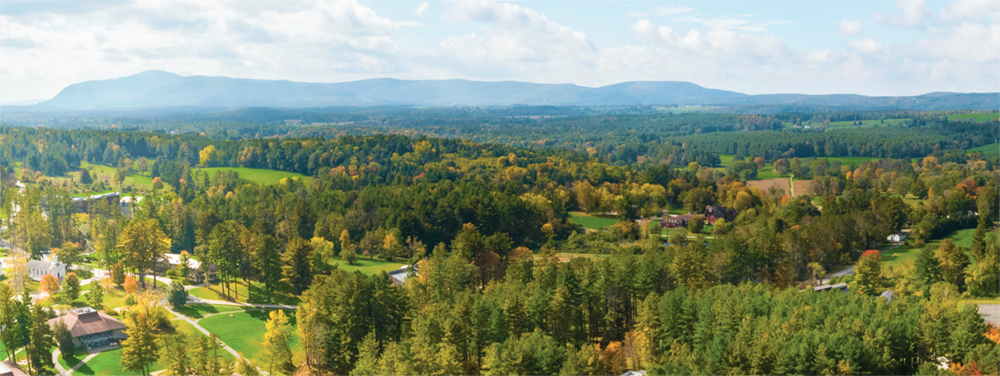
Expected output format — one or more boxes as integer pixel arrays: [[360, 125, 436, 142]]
[[0, 104, 1000, 375]]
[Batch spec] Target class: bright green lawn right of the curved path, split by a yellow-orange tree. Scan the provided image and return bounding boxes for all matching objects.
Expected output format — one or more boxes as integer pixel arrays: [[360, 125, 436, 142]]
[[198, 311, 302, 363]]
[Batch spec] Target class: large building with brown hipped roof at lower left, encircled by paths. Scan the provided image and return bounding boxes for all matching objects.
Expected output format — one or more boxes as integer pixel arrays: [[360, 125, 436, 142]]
[[49, 307, 127, 352]]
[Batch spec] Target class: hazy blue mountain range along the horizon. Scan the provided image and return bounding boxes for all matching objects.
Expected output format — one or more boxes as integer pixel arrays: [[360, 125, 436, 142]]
[[11, 71, 1000, 112]]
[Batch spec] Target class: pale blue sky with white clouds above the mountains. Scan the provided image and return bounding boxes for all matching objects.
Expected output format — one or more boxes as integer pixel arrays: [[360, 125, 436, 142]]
[[0, 0, 1000, 103]]
